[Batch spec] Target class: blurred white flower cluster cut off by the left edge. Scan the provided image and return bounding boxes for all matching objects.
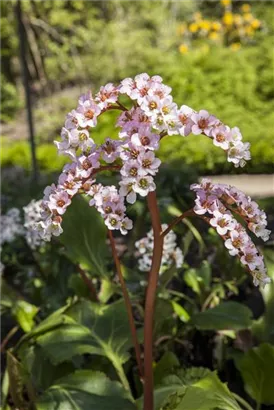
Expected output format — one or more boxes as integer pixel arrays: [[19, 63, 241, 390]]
[[0, 208, 24, 246]]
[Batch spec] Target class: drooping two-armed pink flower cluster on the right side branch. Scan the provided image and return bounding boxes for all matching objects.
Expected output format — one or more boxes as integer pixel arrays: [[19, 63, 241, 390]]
[[191, 179, 270, 286]]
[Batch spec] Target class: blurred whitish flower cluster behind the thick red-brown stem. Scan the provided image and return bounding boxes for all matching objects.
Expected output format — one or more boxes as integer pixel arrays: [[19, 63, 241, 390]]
[[135, 224, 184, 274]]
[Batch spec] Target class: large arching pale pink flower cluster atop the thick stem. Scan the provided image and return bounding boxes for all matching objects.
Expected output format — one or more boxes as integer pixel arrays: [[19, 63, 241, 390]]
[[33, 74, 250, 240]]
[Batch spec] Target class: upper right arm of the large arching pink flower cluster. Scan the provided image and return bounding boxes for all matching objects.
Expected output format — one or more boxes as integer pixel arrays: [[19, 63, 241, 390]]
[[120, 74, 251, 167]]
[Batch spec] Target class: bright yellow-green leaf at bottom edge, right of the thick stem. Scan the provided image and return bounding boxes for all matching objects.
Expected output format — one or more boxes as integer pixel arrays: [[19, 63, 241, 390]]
[[174, 373, 241, 410]]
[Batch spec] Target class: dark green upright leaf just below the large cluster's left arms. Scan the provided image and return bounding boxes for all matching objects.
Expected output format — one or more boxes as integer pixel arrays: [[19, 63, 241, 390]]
[[60, 197, 108, 276]]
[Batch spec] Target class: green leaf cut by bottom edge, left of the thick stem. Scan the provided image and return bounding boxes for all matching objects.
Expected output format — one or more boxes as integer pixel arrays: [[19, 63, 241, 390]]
[[36, 370, 136, 410]]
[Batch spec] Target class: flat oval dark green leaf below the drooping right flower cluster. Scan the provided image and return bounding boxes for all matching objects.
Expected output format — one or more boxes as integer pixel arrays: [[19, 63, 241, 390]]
[[191, 302, 252, 330]]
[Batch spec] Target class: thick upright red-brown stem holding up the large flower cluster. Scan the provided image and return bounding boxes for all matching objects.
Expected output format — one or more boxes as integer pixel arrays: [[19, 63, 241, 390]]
[[143, 191, 164, 410]]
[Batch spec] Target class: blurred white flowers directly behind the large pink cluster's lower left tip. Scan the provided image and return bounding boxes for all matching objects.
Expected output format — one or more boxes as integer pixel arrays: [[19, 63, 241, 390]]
[[23, 199, 43, 249]]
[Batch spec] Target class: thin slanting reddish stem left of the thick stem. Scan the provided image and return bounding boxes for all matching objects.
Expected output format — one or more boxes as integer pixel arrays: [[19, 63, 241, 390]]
[[108, 230, 144, 380]]
